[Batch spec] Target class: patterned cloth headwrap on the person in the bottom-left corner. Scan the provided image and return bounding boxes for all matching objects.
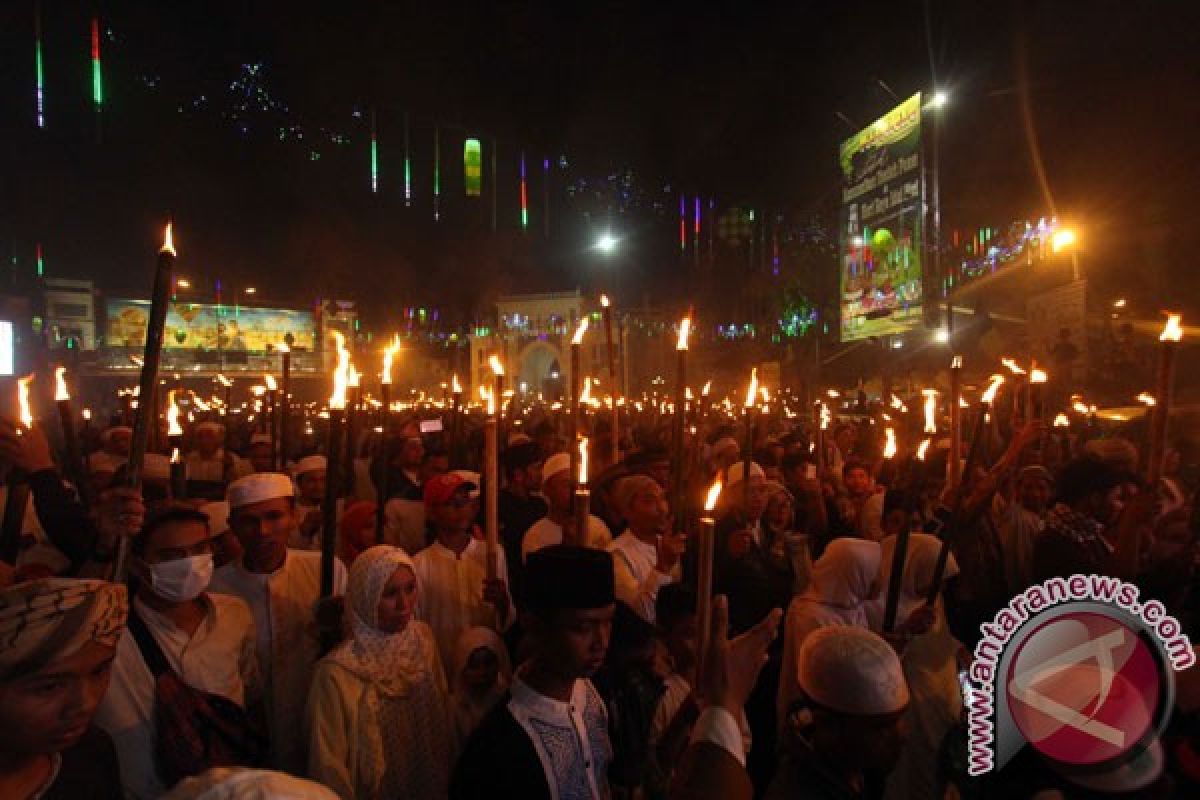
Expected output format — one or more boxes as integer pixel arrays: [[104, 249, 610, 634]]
[[0, 578, 130, 681]]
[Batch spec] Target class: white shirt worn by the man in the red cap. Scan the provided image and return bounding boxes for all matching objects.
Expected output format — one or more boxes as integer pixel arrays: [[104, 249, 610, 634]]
[[413, 539, 515, 682]]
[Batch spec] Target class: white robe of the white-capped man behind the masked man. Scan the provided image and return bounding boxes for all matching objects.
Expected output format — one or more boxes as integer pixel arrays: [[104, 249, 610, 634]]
[[210, 551, 346, 775]]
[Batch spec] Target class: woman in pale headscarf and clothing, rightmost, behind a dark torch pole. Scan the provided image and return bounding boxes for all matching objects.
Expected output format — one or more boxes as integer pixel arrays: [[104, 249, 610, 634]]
[[868, 533, 962, 798]]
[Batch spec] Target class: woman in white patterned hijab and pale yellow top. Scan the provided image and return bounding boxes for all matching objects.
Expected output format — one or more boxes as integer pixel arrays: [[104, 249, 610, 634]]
[[308, 545, 452, 799]]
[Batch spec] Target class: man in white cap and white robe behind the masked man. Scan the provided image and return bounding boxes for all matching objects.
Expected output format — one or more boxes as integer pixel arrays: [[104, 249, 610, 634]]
[[212, 473, 346, 775]]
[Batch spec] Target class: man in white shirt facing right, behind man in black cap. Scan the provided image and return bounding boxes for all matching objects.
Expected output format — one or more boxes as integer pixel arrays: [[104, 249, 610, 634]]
[[608, 475, 688, 625]]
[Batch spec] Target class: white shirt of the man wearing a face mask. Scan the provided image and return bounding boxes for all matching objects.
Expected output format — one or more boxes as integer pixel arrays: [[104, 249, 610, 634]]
[[95, 595, 260, 798]]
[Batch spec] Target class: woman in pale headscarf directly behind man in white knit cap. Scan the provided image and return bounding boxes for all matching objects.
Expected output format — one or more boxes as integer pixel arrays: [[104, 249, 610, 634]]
[[775, 537, 880, 726]]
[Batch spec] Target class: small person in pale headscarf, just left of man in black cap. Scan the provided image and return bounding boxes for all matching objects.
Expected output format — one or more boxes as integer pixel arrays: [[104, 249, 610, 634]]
[[450, 625, 512, 747]]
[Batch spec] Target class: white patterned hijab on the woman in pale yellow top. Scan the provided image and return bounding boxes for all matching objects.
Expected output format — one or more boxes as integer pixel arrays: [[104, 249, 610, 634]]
[[329, 545, 433, 696]]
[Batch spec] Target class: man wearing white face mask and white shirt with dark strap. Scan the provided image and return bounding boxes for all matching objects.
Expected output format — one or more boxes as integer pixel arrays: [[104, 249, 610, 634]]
[[96, 506, 262, 799]]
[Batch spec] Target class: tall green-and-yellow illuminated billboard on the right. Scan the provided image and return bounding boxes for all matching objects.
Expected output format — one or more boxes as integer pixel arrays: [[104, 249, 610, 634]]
[[839, 92, 923, 342]]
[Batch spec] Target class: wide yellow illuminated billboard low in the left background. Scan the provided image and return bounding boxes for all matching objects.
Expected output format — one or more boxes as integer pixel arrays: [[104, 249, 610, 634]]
[[106, 299, 316, 353]]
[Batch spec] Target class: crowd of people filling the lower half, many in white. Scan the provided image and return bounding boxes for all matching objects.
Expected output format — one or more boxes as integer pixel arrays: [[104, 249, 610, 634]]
[[0, 395, 1200, 800]]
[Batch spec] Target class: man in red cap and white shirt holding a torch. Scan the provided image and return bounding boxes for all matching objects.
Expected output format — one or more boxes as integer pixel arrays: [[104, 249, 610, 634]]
[[413, 473, 515, 679]]
